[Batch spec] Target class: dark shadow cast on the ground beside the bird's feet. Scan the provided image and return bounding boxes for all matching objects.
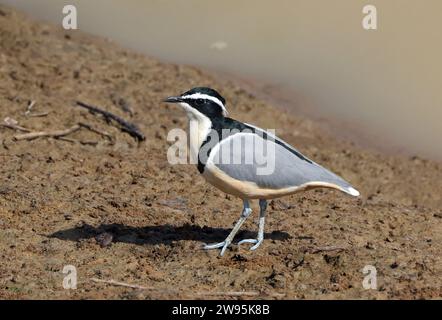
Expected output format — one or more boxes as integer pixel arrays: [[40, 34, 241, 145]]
[[49, 223, 291, 245]]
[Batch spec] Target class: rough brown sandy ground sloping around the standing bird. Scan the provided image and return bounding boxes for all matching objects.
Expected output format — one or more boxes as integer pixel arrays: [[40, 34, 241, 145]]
[[0, 7, 442, 299]]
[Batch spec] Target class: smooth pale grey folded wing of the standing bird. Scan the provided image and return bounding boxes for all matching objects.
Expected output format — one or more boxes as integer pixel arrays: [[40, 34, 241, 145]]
[[210, 133, 356, 195]]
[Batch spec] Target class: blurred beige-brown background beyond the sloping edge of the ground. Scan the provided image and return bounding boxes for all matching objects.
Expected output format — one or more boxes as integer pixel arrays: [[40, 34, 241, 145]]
[[0, 0, 442, 159]]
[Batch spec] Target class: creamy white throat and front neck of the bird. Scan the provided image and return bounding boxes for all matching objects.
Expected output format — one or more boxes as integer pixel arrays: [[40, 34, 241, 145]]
[[180, 102, 212, 163]]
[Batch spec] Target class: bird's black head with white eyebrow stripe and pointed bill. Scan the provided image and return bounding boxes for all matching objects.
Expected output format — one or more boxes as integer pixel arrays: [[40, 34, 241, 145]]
[[164, 87, 227, 119]]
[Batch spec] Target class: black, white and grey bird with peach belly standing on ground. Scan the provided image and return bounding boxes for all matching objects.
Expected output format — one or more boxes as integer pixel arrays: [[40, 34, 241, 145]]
[[163, 87, 360, 256]]
